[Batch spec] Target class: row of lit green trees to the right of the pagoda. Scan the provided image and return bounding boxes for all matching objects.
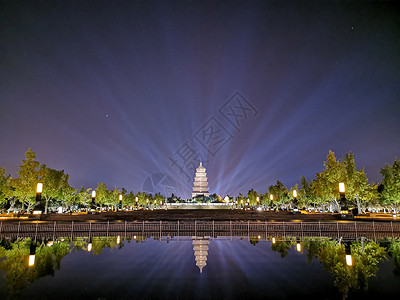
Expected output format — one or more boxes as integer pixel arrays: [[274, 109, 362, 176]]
[[236, 151, 400, 213]]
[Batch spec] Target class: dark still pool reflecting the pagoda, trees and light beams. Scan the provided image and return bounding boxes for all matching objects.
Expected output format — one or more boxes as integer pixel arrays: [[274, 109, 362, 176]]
[[0, 237, 400, 299]]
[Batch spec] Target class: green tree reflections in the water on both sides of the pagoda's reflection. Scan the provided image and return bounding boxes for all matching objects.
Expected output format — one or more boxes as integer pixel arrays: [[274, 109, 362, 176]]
[[0, 236, 400, 299]]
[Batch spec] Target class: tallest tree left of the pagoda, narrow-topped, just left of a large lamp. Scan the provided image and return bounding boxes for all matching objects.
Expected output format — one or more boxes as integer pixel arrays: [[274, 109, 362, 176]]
[[10, 148, 43, 211]]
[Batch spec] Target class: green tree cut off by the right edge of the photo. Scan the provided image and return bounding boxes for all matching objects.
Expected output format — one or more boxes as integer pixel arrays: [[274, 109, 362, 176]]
[[381, 159, 400, 213]]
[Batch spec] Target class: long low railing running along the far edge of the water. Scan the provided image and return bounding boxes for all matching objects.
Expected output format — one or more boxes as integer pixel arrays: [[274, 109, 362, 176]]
[[0, 221, 400, 241]]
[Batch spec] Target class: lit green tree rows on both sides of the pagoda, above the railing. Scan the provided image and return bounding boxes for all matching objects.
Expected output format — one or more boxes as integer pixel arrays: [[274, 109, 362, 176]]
[[0, 148, 400, 212]]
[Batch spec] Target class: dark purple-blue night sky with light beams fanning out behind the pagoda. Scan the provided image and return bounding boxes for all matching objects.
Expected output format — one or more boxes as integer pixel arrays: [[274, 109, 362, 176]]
[[0, 0, 400, 197]]
